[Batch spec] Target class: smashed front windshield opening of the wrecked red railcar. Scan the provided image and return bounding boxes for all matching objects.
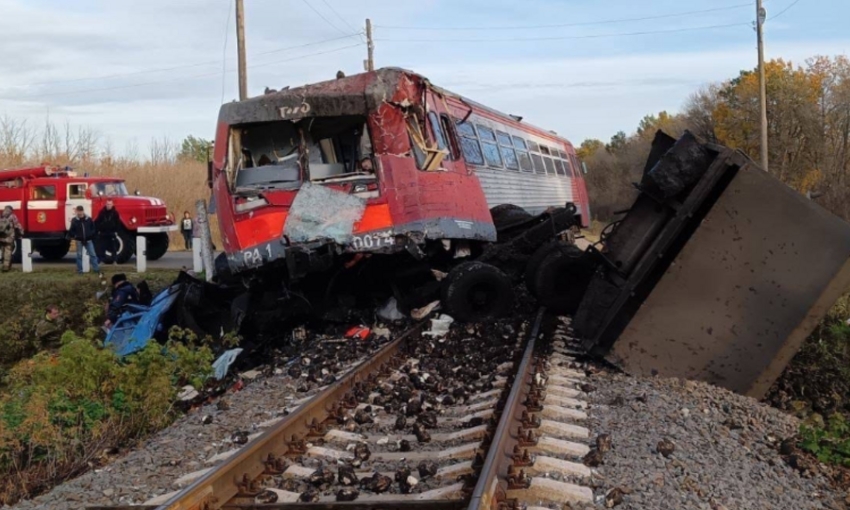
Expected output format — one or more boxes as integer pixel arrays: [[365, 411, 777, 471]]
[[227, 116, 374, 191]]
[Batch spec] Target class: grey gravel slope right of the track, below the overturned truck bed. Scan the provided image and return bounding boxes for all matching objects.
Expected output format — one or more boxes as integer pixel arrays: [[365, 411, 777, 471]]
[[590, 371, 846, 510]]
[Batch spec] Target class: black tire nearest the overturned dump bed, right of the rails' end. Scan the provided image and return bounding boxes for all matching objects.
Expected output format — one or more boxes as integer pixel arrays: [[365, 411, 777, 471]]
[[533, 245, 596, 315]]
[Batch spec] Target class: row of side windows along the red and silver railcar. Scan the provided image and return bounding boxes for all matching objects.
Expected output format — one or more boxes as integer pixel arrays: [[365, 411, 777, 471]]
[[455, 120, 577, 177]]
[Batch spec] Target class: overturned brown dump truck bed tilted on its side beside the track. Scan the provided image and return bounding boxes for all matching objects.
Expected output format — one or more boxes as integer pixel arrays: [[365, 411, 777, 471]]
[[574, 133, 850, 397]]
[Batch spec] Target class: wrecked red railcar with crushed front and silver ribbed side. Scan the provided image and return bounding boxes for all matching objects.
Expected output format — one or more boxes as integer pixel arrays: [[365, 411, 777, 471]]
[[209, 68, 590, 317]]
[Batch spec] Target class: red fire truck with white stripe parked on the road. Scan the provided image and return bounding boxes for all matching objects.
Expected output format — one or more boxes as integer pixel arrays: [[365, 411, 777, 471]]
[[0, 165, 177, 263]]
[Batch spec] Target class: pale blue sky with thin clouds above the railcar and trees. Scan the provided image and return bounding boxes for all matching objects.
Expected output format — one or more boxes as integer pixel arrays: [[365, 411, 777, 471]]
[[0, 0, 850, 157]]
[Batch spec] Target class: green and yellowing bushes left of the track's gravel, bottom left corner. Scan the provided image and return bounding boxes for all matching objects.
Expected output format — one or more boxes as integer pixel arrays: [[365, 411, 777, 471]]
[[0, 330, 213, 504]]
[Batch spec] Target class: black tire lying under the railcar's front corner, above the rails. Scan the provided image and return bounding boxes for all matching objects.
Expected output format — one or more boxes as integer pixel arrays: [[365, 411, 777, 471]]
[[442, 261, 514, 322]]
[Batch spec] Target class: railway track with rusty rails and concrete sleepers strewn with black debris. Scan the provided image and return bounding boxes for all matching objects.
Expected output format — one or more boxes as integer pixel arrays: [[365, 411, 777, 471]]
[[88, 310, 588, 510]]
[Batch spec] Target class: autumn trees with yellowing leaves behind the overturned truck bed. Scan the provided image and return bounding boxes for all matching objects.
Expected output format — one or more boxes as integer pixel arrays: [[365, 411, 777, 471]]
[[578, 56, 850, 221]]
